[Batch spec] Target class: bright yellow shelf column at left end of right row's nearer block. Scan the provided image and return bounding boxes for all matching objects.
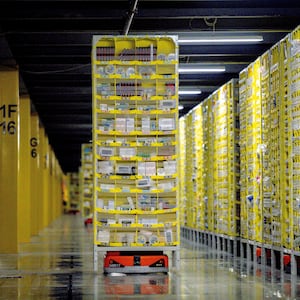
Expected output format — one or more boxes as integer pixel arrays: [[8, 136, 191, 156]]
[[239, 59, 265, 242]]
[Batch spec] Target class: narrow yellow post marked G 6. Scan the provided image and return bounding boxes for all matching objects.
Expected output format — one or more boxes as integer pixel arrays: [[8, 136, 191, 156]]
[[30, 113, 40, 235]]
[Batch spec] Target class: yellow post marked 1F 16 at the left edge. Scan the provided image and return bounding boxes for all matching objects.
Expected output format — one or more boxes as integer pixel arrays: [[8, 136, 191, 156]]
[[0, 70, 20, 253]]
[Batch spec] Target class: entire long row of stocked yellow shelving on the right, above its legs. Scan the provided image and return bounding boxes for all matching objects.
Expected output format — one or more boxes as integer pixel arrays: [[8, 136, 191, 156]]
[[184, 27, 300, 253]]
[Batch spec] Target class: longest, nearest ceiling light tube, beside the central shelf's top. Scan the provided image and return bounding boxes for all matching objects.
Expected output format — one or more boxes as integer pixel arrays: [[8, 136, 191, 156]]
[[178, 36, 264, 44]]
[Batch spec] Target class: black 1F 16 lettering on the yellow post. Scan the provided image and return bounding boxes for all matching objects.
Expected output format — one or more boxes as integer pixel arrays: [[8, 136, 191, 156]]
[[0, 104, 18, 135]]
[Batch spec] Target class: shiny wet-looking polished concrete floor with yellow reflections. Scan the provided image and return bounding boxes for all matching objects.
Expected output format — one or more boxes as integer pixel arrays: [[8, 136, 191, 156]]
[[0, 215, 300, 300]]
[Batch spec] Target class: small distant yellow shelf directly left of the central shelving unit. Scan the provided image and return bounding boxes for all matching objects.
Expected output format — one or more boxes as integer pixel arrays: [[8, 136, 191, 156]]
[[80, 144, 93, 218]]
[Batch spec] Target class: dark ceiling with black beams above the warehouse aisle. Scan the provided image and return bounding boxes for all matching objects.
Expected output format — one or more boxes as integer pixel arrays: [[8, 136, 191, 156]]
[[0, 0, 300, 172]]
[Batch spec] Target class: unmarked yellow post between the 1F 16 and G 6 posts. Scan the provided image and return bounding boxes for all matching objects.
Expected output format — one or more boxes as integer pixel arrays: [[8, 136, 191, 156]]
[[18, 96, 31, 243]]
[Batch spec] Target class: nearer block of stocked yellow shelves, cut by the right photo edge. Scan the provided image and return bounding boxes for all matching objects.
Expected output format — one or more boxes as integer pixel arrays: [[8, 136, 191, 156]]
[[240, 29, 300, 251]]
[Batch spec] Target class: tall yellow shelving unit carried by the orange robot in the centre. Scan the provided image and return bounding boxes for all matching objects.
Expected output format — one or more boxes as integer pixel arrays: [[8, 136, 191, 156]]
[[92, 36, 179, 271]]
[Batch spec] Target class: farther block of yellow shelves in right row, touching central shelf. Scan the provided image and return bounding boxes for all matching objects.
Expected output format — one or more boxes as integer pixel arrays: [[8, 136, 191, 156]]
[[180, 80, 240, 236]]
